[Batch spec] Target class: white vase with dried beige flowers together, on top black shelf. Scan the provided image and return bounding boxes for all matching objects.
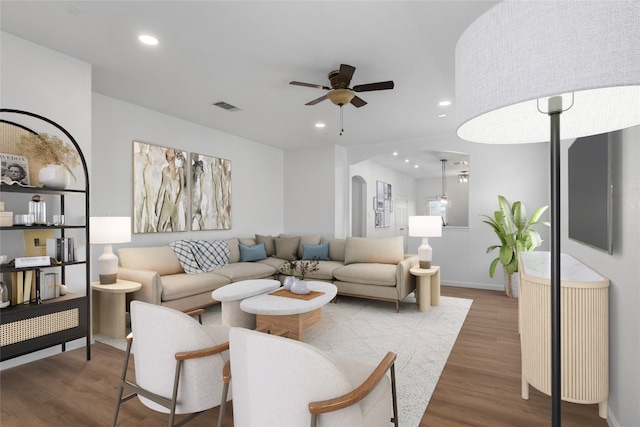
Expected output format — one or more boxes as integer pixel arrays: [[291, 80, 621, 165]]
[[21, 133, 79, 189]]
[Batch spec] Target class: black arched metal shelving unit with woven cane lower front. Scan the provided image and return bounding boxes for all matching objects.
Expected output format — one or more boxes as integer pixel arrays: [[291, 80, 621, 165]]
[[0, 109, 91, 360]]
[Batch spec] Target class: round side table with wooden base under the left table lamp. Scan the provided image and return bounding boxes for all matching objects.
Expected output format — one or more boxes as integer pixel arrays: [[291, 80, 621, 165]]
[[91, 279, 142, 339]]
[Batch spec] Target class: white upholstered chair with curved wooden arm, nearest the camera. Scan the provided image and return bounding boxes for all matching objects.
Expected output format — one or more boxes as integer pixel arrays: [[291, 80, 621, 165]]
[[229, 328, 398, 427]]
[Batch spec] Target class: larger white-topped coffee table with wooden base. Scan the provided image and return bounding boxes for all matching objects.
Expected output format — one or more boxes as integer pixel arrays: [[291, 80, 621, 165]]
[[240, 281, 338, 341]]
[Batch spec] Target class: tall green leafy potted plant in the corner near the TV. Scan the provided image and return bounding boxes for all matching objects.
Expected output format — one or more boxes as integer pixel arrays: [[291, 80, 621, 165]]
[[483, 196, 549, 296]]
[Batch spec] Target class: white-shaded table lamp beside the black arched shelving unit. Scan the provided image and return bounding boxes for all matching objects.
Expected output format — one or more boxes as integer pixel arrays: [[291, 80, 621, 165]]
[[89, 216, 131, 285]]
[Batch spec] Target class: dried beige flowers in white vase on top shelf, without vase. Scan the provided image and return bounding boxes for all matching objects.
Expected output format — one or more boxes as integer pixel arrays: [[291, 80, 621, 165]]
[[20, 132, 80, 180]]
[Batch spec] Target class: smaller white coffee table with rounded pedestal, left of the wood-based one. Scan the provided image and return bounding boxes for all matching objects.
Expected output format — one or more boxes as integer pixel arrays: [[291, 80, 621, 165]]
[[211, 279, 281, 329]]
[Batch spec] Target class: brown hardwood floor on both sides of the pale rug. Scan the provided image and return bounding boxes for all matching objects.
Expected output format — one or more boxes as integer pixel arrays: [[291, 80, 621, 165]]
[[0, 287, 607, 427]]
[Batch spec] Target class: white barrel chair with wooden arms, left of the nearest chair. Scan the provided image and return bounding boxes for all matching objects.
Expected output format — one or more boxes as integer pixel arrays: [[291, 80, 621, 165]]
[[113, 301, 231, 427]]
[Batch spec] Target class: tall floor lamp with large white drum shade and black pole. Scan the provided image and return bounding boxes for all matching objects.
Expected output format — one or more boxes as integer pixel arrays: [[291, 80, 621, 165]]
[[456, 0, 640, 427]]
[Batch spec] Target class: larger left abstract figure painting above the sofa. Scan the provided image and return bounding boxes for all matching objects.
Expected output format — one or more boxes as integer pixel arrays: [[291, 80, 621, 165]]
[[133, 141, 187, 233]]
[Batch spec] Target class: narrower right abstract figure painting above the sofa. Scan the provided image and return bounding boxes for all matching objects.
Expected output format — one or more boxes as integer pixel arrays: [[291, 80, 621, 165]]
[[191, 153, 231, 230]]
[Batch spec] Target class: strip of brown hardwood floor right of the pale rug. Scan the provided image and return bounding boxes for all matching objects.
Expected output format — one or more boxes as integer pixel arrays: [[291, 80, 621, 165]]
[[420, 286, 608, 427]]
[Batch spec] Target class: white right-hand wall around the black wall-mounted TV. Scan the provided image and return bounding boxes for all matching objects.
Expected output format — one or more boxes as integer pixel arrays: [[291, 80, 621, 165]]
[[560, 126, 640, 427]]
